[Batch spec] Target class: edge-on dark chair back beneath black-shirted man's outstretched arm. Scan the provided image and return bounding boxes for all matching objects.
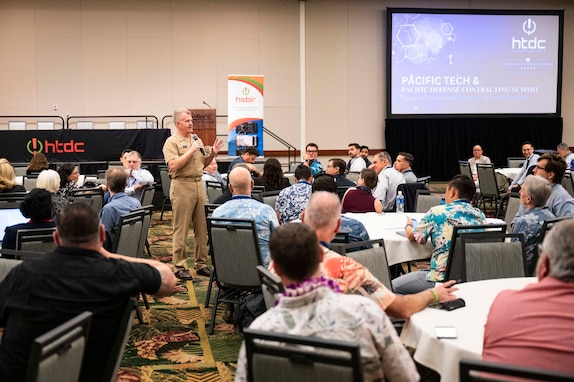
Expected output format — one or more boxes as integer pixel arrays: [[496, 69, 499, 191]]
[[102, 297, 137, 382]]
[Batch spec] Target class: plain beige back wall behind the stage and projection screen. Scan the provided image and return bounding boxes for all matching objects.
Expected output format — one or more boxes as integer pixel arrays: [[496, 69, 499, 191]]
[[0, 0, 574, 156]]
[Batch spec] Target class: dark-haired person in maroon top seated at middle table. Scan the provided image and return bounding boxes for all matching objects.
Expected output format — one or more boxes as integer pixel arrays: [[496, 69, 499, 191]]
[[343, 168, 383, 213]]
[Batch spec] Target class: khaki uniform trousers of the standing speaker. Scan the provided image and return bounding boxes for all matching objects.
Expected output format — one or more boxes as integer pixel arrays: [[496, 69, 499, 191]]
[[169, 176, 208, 270]]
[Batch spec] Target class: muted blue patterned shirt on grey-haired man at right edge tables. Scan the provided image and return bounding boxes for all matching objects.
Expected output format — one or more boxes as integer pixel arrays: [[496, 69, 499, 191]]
[[512, 206, 555, 268]]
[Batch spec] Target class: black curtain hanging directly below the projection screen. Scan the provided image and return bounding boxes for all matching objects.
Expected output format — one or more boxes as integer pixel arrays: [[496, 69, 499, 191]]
[[385, 117, 562, 181]]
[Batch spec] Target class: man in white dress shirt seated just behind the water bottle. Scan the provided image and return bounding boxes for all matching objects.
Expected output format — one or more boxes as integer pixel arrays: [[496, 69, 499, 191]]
[[373, 151, 405, 211]]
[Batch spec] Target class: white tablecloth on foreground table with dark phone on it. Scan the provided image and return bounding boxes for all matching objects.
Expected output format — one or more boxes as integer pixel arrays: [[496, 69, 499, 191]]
[[401, 277, 536, 381]]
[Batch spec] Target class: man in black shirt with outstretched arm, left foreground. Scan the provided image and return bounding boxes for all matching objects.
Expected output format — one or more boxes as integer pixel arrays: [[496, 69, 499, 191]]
[[0, 201, 175, 382]]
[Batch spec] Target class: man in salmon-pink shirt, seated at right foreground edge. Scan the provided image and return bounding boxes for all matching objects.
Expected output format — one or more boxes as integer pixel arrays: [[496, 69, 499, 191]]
[[482, 219, 574, 374]]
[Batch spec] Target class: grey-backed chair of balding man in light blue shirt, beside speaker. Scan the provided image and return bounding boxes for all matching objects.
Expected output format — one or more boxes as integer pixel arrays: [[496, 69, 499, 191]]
[[207, 217, 262, 334]]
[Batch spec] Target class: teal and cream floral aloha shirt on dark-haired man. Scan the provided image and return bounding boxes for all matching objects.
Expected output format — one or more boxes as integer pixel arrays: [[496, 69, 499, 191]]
[[414, 199, 486, 281]]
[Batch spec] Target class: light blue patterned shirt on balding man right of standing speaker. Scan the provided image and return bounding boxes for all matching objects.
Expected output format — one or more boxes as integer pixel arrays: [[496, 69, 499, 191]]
[[211, 195, 279, 267]]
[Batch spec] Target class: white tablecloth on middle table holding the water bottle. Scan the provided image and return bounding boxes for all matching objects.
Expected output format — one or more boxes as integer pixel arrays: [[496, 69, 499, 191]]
[[345, 212, 433, 265]]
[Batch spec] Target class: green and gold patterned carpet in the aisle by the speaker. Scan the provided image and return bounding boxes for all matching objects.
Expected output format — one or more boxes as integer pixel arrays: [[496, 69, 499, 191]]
[[116, 211, 241, 382]]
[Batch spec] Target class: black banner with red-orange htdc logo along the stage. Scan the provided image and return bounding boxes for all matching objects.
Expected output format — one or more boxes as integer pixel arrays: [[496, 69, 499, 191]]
[[0, 129, 171, 163]]
